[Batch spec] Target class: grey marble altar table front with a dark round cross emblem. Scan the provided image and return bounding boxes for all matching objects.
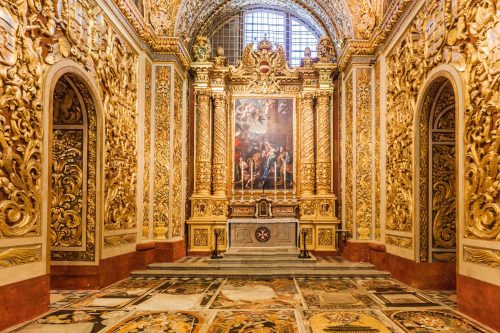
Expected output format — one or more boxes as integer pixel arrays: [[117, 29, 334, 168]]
[[227, 218, 299, 249]]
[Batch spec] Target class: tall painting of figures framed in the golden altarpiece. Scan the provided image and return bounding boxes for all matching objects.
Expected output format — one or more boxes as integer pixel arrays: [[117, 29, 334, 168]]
[[233, 98, 294, 191]]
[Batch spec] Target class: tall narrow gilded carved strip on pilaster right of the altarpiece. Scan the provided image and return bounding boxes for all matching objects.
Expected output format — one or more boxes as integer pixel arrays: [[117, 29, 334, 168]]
[[356, 68, 373, 239]]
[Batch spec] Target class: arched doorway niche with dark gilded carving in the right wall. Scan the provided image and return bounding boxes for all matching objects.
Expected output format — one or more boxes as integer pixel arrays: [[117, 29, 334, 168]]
[[417, 77, 458, 263]]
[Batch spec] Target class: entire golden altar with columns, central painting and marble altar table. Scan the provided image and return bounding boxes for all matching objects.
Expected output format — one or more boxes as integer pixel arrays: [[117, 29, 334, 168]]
[[187, 38, 340, 254]]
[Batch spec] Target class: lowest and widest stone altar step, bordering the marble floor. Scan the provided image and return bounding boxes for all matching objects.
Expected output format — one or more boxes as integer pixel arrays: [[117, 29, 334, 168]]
[[132, 268, 390, 278]]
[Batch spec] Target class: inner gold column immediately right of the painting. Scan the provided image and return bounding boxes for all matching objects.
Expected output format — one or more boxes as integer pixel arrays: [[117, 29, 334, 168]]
[[300, 93, 314, 195]]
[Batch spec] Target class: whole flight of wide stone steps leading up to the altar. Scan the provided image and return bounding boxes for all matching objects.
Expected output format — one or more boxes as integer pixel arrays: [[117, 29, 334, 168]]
[[132, 251, 389, 277]]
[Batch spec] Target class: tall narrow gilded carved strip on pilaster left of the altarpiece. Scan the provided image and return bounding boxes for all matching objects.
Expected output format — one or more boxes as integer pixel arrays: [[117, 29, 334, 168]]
[[153, 66, 172, 239]]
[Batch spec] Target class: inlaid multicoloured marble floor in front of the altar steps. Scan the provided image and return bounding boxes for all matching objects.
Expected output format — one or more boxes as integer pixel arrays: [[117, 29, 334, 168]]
[[6, 277, 489, 333]]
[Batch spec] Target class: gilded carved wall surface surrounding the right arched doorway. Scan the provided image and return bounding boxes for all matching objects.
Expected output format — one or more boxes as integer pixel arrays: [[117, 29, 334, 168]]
[[387, 0, 500, 249]]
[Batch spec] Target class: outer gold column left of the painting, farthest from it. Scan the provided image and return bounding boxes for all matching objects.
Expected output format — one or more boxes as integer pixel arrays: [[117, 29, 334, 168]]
[[195, 90, 212, 195]]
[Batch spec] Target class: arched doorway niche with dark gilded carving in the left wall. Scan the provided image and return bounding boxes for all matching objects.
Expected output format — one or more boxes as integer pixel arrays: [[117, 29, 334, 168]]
[[48, 73, 99, 265]]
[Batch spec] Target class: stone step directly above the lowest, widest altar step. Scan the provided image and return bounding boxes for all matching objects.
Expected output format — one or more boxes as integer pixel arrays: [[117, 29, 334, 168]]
[[148, 261, 374, 271]]
